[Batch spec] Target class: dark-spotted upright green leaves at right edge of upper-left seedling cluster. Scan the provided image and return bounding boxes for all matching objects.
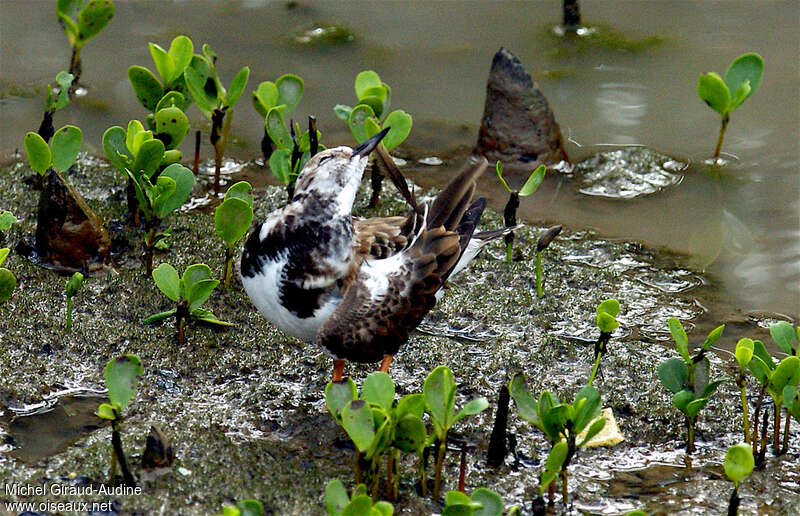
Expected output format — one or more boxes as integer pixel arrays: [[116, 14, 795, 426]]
[[183, 44, 250, 117]]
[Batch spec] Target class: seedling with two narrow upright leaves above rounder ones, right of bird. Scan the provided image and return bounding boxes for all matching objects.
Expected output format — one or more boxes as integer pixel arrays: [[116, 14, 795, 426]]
[[658, 317, 725, 454]]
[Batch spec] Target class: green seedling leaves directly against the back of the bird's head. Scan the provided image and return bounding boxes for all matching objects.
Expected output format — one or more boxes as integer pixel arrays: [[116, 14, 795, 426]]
[[265, 112, 325, 200]]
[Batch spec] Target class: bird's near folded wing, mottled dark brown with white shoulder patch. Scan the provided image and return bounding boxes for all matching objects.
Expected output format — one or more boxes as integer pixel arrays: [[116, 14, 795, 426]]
[[317, 227, 460, 362]]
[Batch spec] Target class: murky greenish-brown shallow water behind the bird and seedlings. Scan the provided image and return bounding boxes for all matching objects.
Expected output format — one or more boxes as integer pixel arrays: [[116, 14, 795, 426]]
[[0, 0, 800, 319]]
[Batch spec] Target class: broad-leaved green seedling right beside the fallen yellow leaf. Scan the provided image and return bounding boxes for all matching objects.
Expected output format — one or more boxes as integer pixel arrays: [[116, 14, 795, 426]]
[[509, 374, 606, 505]]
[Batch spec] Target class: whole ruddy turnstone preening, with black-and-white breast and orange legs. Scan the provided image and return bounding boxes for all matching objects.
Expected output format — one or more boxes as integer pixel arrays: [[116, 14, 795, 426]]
[[240, 128, 503, 381]]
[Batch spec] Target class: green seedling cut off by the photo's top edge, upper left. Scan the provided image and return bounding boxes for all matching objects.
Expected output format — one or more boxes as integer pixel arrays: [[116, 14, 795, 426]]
[[56, 0, 114, 84]]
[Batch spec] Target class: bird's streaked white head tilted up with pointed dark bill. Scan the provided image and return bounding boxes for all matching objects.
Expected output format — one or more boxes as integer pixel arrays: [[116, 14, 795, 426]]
[[294, 127, 389, 206]]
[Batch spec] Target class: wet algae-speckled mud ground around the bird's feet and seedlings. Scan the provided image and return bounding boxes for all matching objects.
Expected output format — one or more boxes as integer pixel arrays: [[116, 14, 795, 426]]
[[0, 156, 800, 515]]
